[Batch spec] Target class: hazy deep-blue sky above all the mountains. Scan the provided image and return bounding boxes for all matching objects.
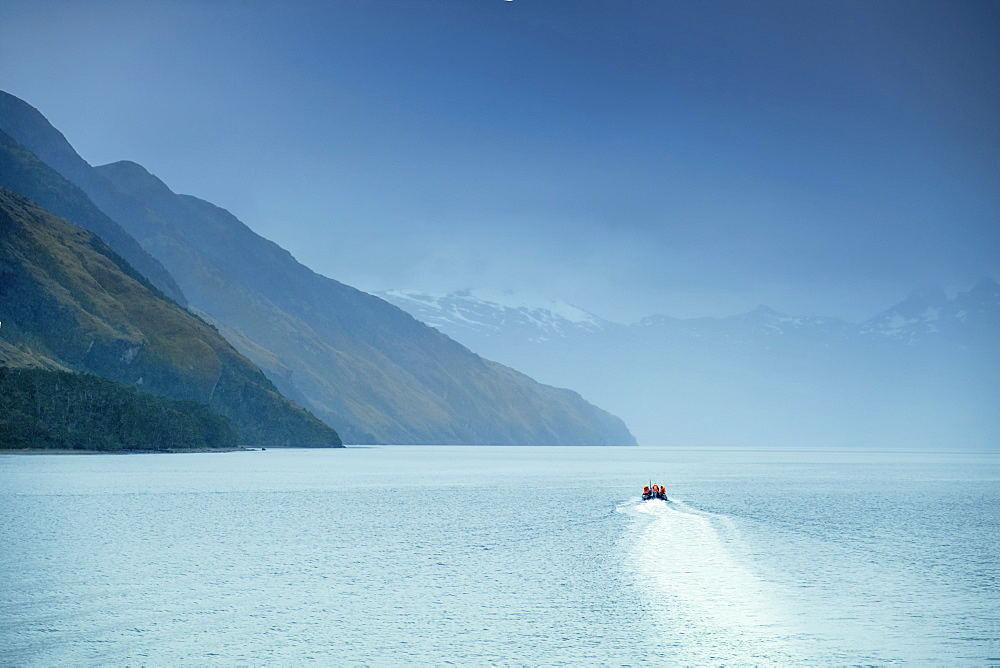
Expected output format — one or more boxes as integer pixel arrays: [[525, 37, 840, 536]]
[[0, 0, 1000, 320]]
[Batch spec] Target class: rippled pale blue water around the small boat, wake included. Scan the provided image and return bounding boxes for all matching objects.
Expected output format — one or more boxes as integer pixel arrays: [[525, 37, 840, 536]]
[[0, 447, 1000, 666]]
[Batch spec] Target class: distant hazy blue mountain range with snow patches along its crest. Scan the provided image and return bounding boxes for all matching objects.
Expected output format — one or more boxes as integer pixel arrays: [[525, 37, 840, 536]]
[[381, 279, 1000, 447]]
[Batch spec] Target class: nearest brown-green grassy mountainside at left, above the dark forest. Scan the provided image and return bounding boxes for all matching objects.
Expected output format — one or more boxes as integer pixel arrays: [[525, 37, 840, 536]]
[[0, 189, 340, 446]]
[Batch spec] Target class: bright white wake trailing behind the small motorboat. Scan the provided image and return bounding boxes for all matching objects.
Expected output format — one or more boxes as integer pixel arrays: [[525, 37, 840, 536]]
[[620, 500, 803, 664]]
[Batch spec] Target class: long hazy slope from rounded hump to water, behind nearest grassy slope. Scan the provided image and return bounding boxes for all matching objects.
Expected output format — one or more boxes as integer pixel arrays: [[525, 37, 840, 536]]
[[98, 162, 634, 445]]
